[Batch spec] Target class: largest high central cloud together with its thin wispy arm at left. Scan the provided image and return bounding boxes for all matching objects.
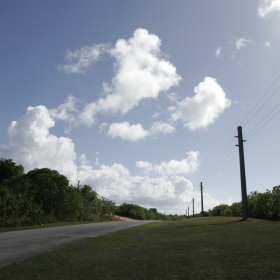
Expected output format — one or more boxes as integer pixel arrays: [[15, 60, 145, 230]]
[[57, 29, 181, 125]]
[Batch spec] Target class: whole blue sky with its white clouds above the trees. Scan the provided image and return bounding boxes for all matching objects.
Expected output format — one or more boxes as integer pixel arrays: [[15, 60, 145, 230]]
[[0, 0, 280, 214]]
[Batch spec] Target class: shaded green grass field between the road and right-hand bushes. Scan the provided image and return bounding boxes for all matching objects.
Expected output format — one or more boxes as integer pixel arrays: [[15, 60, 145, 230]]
[[0, 217, 280, 280]]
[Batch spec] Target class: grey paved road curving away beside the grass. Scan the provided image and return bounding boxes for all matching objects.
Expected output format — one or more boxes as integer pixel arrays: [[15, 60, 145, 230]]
[[0, 221, 151, 267]]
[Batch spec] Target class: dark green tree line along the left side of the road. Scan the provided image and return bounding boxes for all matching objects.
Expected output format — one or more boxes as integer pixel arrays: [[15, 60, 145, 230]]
[[0, 158, 185, 227]]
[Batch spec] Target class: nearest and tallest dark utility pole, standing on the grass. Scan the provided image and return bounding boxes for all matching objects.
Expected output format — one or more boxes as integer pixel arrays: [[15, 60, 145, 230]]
[[235, 126, 248, 220]]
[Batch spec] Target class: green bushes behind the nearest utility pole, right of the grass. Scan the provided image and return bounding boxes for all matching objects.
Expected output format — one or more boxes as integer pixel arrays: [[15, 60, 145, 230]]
[[208, 186, 280, 220]]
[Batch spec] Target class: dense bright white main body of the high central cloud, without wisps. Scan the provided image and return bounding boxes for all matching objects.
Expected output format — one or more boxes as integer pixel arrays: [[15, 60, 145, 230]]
[[99, 29, 180, 113]]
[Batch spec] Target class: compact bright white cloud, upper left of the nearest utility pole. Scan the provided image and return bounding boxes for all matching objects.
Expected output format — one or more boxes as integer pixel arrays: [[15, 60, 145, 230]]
[[169, 77, 231, 130]]
